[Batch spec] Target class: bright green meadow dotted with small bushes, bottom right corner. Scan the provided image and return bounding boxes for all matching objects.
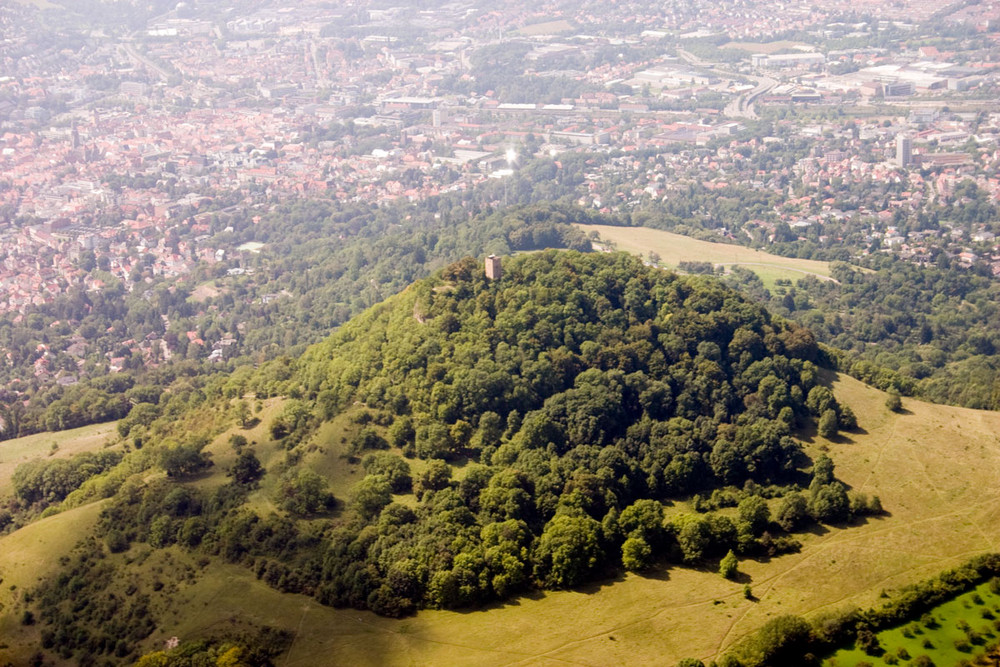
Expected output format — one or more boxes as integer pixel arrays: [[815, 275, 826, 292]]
[[823, 583, 1000, 667]]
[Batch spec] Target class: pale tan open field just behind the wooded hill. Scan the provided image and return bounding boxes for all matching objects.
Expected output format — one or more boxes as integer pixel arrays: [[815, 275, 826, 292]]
[[577, 225, 830, 289]]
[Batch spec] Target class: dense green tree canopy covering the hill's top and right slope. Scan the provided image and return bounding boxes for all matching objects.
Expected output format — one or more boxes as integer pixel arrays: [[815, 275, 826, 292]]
[[227, 252, 842, 615]]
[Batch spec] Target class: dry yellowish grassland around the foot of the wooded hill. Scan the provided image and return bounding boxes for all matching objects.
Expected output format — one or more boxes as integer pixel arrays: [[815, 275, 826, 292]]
[[0, 374, 1000, 666]]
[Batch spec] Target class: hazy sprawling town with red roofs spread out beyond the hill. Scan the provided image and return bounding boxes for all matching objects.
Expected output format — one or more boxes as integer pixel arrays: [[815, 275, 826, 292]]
[[0, 1, 1000, 428]]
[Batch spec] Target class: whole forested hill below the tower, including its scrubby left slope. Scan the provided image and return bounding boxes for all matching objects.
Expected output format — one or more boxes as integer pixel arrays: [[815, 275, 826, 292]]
[[19, 251, 877, 664]]
